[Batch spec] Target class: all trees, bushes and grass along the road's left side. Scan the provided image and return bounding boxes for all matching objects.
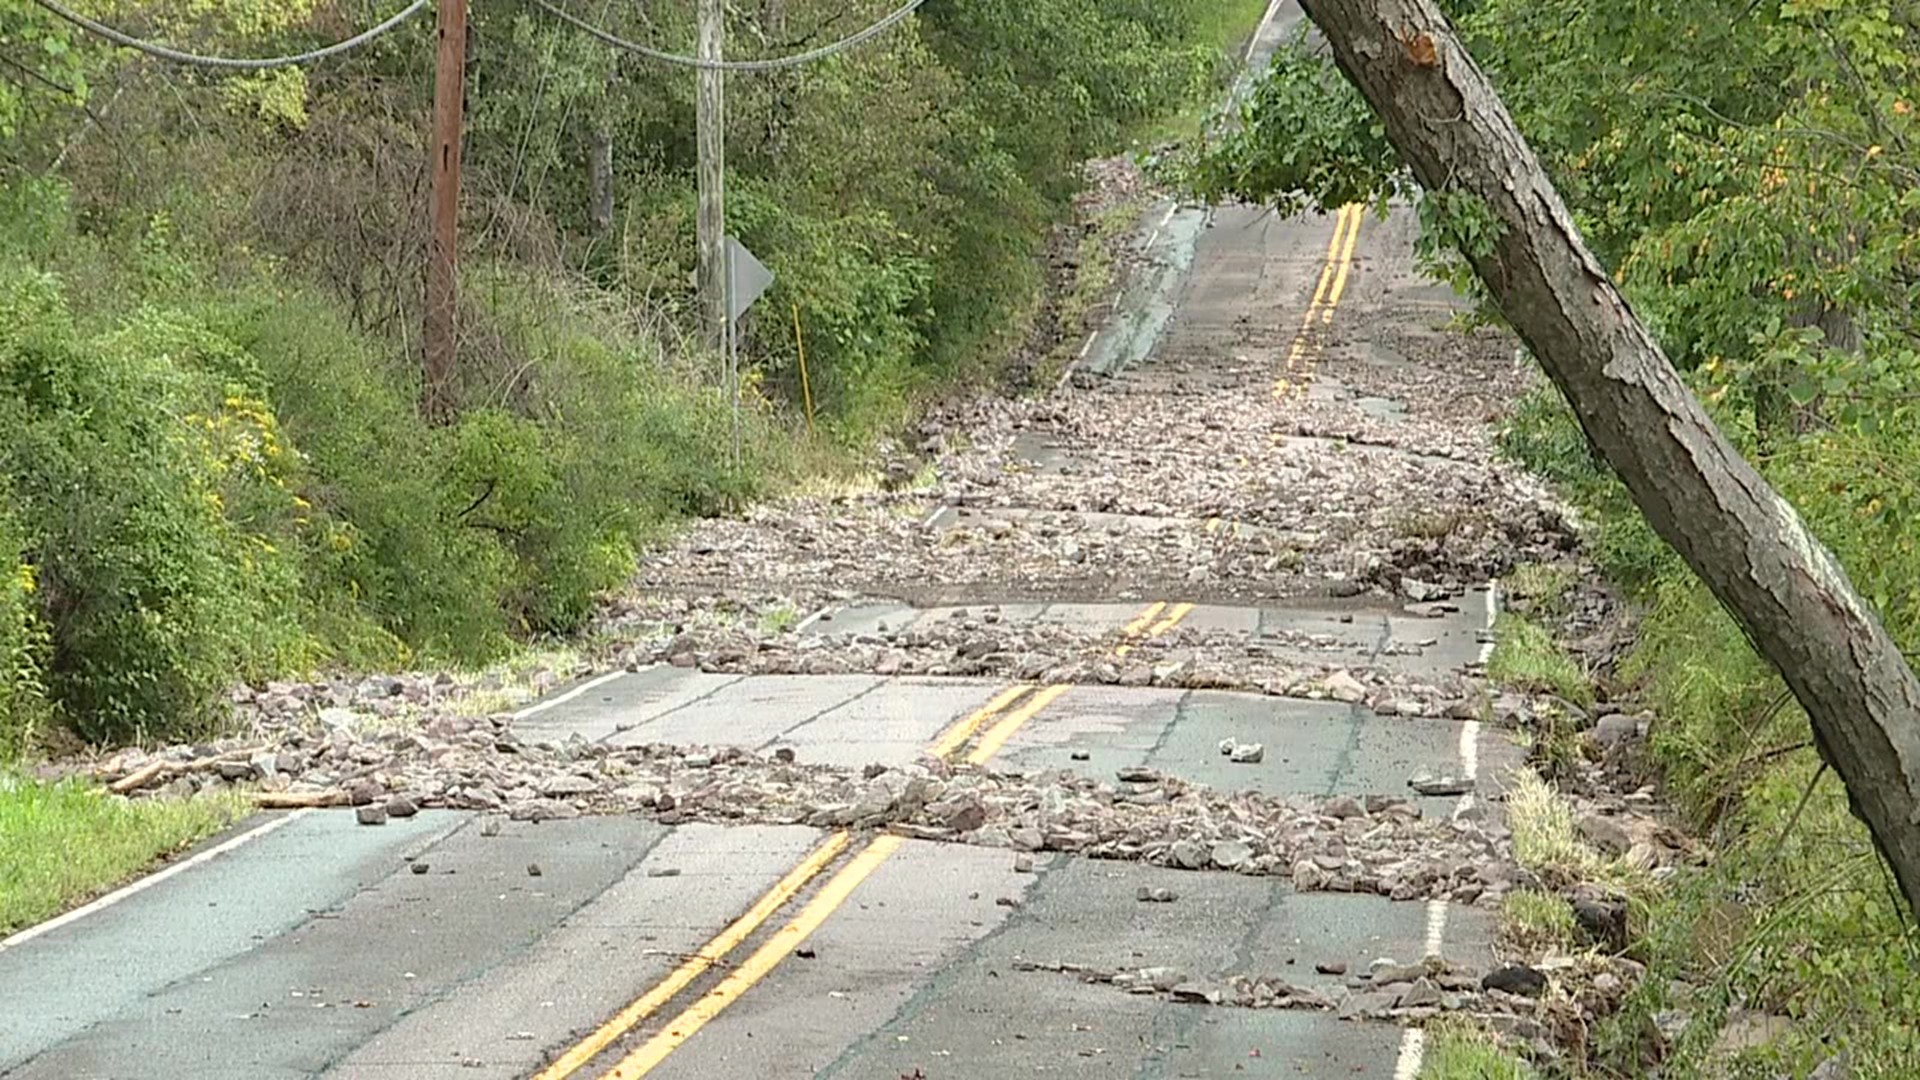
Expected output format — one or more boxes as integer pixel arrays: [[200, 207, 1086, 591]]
[[0, 0, 1263, 932]]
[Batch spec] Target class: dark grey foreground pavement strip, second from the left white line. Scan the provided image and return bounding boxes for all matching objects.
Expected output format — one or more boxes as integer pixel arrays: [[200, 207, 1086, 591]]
[[8, 813, 666, 1080]]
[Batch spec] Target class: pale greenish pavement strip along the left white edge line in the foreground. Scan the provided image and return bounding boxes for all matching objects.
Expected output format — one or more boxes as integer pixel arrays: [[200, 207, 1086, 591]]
[[0, 813, 463, 1076]]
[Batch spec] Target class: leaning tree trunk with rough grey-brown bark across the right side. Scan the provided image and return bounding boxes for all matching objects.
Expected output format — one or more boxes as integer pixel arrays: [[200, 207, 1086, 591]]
[[1302, 0, 1920, 913]]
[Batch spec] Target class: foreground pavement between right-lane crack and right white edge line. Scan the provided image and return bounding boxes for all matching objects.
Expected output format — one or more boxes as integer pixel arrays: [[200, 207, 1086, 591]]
[[802, 855, 1427, 1080]]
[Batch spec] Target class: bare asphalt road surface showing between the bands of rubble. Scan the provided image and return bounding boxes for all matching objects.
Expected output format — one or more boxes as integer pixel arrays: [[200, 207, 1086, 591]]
[[0, 4, 1515, 1080]]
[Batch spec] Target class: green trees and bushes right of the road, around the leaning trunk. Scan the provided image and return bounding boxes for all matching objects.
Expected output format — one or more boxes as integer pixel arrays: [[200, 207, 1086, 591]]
[[1190, 0, 1920, 1078]]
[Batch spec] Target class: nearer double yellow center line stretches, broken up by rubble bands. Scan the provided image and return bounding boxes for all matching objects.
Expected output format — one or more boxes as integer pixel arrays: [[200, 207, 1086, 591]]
[[536, 601, 1194, 1080]]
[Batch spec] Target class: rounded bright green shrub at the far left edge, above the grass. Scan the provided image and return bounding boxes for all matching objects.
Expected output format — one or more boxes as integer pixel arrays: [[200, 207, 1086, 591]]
[[0, 273, 298, 738]]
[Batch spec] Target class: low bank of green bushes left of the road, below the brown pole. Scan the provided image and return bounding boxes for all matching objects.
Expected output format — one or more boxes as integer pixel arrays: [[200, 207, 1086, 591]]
[[0, 187, 783, 748]]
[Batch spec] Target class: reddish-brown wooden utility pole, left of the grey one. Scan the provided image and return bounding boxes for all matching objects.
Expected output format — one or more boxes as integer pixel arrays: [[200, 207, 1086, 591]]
[[420, 0, 467, 419]]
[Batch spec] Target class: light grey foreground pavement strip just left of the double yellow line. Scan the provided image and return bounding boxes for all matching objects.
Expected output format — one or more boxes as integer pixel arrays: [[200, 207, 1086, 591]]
[[326, 824, 820, 1080]]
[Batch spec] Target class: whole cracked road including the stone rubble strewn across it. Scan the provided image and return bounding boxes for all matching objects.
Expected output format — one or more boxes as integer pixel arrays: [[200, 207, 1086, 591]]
[[0, 6, 1571, 1080]]
